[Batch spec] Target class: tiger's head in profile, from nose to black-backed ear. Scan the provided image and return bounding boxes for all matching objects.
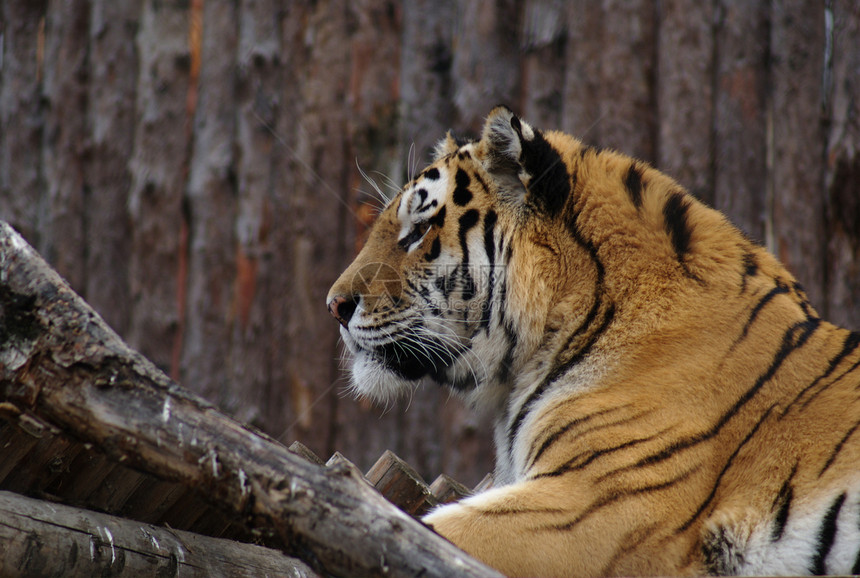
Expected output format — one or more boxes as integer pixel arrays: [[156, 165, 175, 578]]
[[327, 107, 597, 405]]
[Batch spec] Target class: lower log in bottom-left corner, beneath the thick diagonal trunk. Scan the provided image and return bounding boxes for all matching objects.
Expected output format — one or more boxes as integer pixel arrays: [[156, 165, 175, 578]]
[[0, 492, 316, 578]]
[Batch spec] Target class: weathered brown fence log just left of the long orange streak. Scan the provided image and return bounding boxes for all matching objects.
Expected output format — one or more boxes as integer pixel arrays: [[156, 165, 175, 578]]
[[127, 0, 191, 374]]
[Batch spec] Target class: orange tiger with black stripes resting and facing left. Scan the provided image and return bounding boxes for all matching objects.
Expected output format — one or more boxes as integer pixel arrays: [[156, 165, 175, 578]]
[[327, 106, 860, 576]]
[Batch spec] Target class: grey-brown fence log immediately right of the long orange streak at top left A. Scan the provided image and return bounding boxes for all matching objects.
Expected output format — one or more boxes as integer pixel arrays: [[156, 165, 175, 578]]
[[180, 1, 238, 407]]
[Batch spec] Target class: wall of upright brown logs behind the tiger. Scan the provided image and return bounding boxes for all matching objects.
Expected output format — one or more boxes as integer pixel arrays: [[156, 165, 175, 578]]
[[0, 0, 860, 485]]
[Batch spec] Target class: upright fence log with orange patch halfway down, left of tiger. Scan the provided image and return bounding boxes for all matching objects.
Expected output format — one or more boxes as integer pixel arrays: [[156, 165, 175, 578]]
[[228, 0, 282, 432]]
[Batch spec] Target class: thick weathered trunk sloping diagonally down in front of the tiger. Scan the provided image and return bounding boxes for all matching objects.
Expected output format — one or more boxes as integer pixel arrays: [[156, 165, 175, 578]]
[[0, 223, 498, 576]]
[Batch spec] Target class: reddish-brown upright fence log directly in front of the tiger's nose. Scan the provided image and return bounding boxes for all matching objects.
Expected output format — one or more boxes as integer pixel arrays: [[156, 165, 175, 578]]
[[276, 1, 355, 455]]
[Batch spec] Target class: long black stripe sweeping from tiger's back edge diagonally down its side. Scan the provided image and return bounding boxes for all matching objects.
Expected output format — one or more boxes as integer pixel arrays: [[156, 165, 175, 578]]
[[598, 319, 821, 481]]
